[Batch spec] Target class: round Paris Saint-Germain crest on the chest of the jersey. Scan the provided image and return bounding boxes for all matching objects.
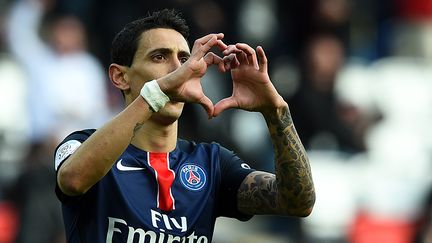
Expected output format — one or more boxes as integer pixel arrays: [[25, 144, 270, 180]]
[[180, 164, 207, 191]]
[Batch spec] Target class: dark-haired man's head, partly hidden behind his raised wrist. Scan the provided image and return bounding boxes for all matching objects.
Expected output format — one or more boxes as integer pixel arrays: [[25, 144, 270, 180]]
[[109, 10, 190, 121]]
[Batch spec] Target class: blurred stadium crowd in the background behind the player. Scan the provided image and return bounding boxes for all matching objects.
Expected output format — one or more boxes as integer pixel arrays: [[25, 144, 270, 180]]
[[0, 0, 432, 243]]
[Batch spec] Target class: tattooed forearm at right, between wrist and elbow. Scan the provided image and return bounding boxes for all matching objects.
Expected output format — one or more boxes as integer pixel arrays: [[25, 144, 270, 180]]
[[264, 103, 315, 216]]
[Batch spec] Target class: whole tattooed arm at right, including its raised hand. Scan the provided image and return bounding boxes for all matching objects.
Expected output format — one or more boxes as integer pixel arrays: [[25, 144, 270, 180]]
[[214, 44, 315, 216]]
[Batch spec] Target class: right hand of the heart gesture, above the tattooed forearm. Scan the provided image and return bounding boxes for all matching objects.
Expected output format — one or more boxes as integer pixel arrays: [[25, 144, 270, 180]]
[[213, 44, 286, 117]]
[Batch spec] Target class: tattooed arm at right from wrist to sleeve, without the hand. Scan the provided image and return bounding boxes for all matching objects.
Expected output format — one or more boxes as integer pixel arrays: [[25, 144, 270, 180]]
[[238, 106, 315, 216]]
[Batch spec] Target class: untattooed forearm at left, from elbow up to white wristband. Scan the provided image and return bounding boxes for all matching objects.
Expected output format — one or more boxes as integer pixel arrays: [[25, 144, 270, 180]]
[[57, 97, 152, 196]]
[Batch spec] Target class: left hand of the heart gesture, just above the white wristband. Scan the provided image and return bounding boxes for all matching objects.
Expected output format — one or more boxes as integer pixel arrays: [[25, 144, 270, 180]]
[[158, 33, 235, 117]]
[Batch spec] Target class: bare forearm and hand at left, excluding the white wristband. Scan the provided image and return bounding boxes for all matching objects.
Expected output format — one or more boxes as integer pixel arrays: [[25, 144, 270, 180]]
[[57, 34, 233, 196]]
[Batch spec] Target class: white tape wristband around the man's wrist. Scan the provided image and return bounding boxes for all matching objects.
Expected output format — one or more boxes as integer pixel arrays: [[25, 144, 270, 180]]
[[140, 80, 170, 112]]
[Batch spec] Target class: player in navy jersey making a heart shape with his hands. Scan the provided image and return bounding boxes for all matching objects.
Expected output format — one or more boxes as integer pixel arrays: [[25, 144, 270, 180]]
[[55, 10, 315, 242]]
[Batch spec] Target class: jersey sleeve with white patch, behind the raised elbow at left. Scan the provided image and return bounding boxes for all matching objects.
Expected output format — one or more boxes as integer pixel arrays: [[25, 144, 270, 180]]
[[54, 129, 96, 202]]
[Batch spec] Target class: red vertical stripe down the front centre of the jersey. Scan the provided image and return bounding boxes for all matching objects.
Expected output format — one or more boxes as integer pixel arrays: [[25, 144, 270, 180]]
[[147, 153, 175, 211]]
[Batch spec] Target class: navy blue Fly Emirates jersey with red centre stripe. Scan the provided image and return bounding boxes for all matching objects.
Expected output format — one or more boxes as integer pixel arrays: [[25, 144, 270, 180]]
[[55, 130, 253, 243]]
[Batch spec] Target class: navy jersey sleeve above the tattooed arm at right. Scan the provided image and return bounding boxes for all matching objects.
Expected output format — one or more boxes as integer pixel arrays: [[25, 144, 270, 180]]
[[218, 146, 255, 221]]
